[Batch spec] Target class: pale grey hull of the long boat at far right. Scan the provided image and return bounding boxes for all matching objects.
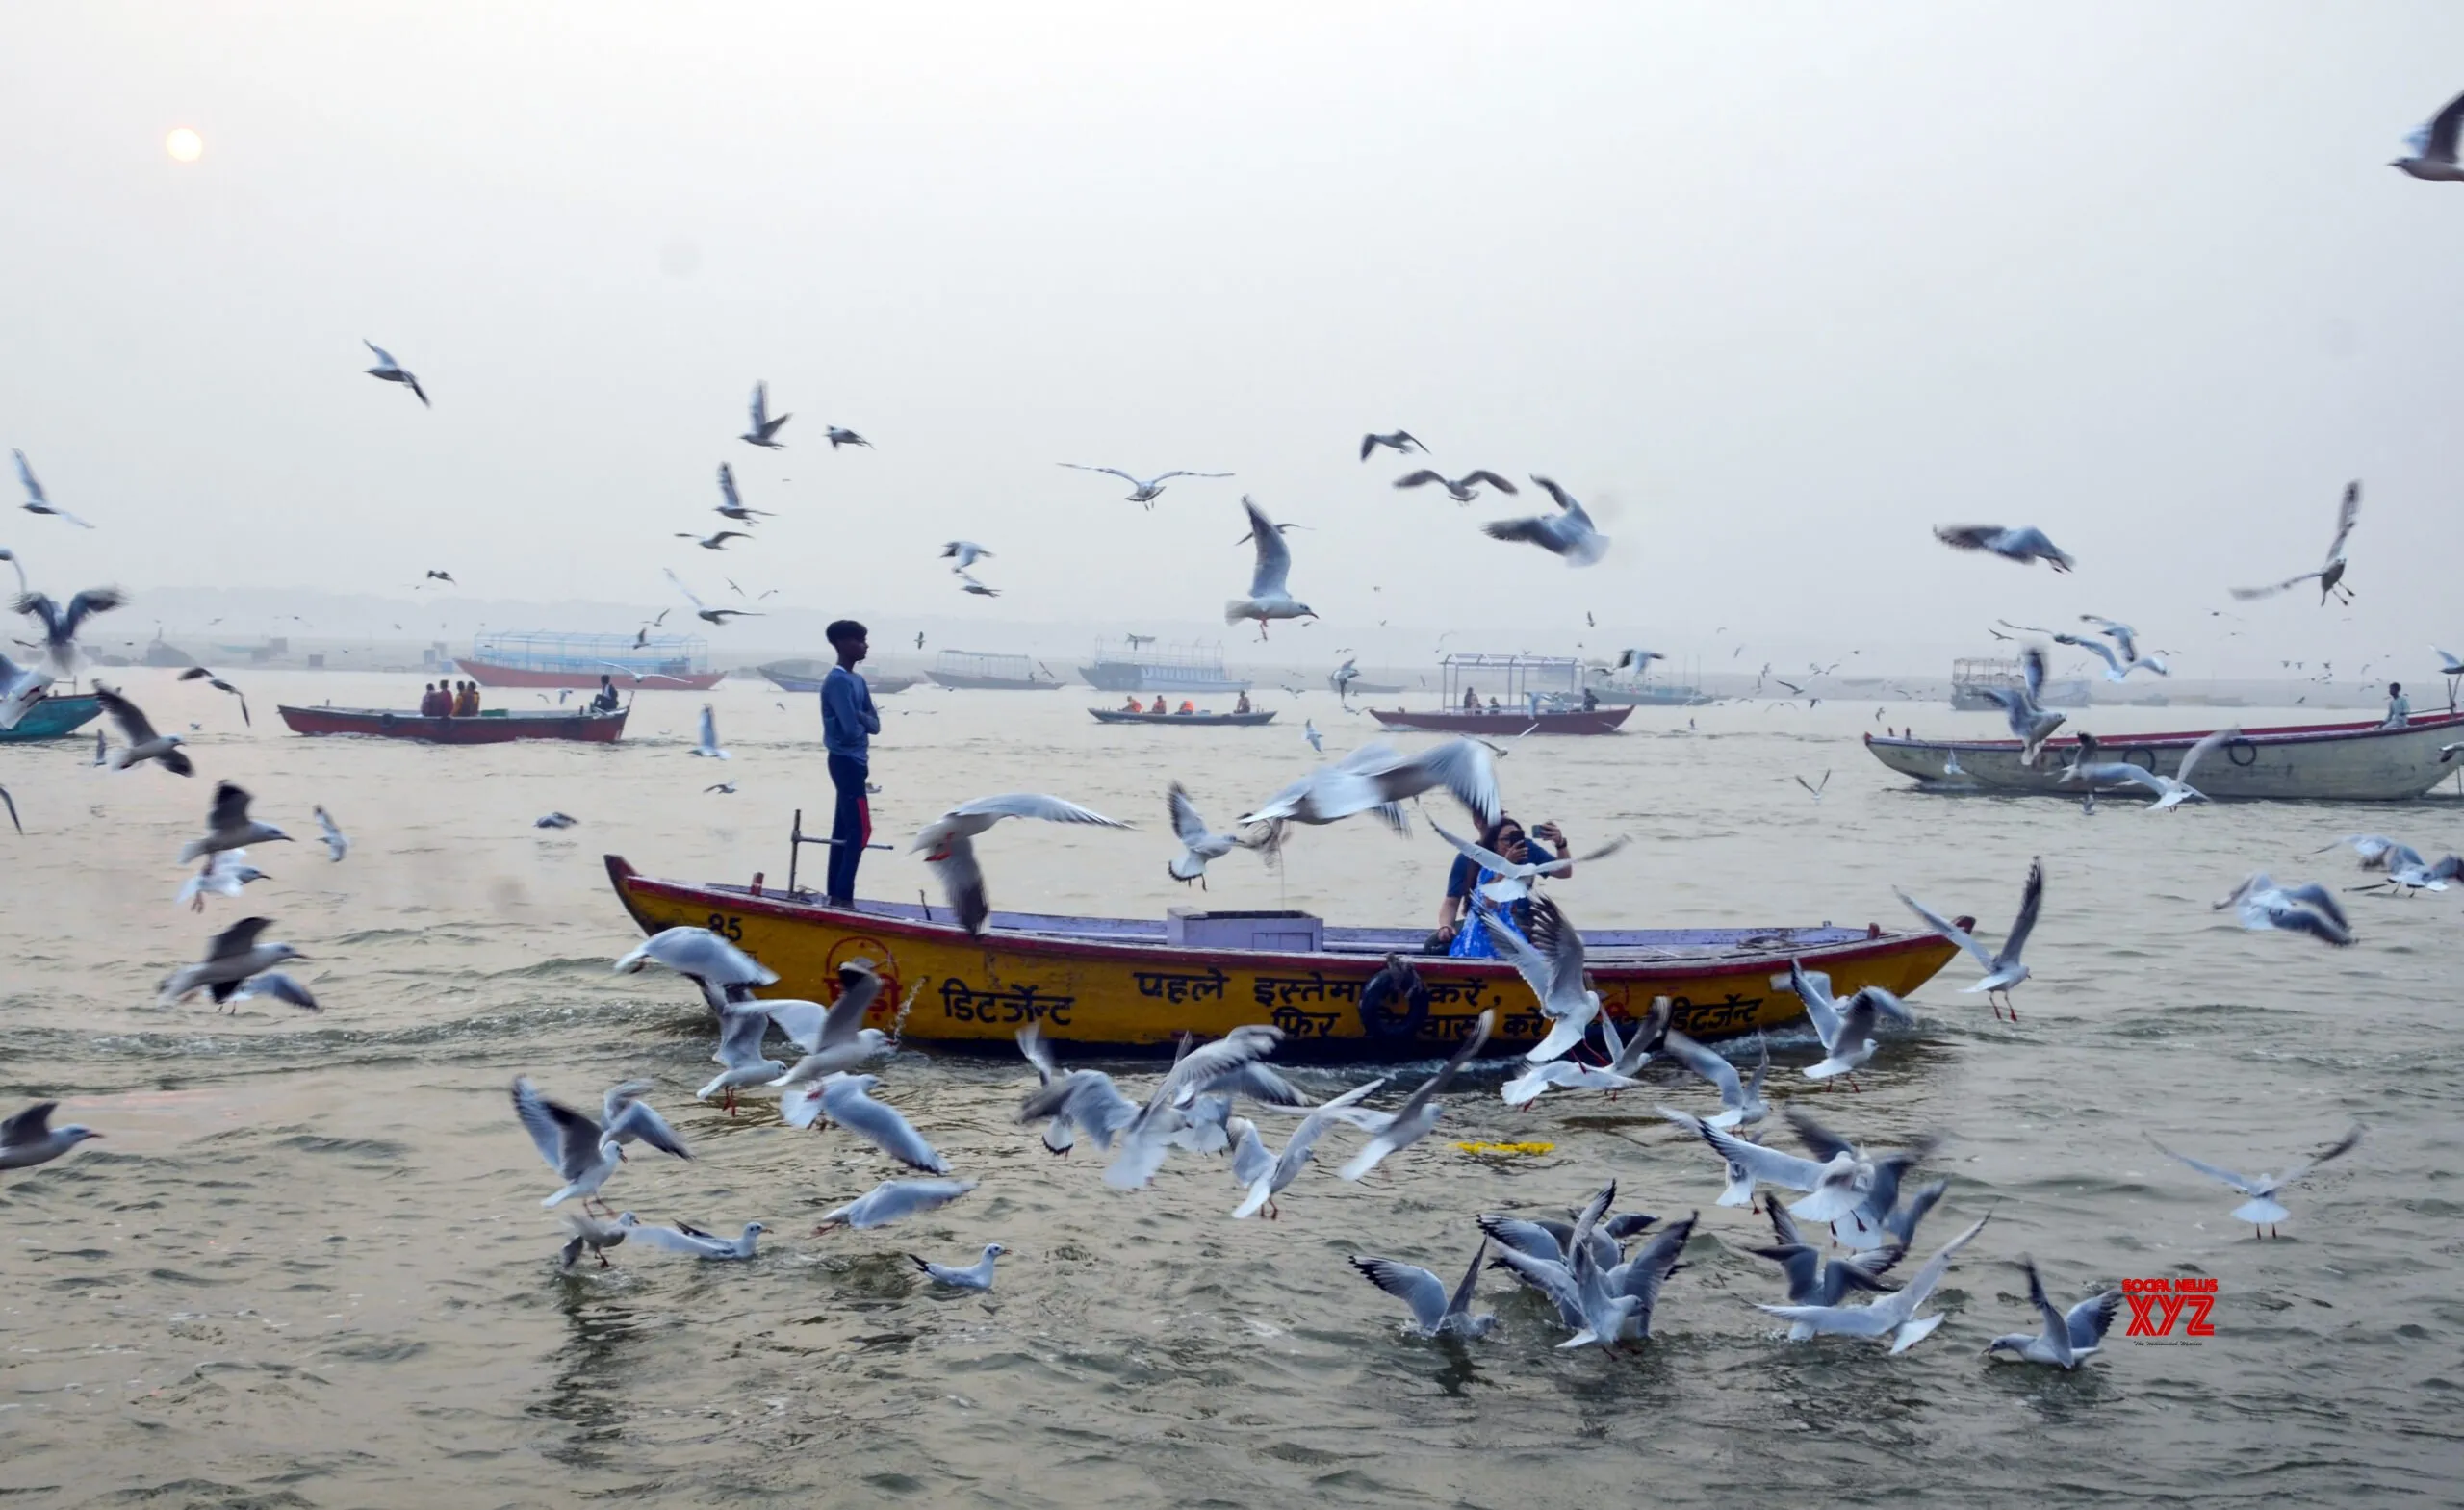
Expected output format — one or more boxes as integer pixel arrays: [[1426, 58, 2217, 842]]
[[1865, 714, 2464, 803]]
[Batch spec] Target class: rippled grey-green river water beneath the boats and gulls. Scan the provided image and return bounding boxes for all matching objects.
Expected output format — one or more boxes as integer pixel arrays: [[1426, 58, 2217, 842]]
[[0, 670, 2464, 1510]]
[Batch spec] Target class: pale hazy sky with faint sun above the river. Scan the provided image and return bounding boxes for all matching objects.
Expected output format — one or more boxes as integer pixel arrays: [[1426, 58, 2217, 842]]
[[0, 0, 2464, 679]]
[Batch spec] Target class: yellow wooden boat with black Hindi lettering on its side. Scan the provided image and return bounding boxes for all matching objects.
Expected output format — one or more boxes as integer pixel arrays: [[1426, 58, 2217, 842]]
[[606, 855, 1971, 1062]]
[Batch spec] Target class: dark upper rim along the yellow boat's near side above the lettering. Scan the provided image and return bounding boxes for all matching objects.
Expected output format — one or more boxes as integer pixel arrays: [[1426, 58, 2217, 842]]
[[603, 855, 1957, 985]]
